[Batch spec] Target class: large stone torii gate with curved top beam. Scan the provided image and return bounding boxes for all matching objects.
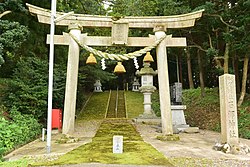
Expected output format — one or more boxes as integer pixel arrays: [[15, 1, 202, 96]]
[[27, 4, 203, 135]]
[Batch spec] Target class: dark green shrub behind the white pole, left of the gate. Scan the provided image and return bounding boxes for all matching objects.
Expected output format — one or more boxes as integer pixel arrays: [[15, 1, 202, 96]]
[[3, 57, 66, 119]]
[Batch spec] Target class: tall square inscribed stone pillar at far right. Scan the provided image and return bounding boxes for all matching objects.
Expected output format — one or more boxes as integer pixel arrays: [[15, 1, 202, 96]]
[[219, 74, 239, 145]]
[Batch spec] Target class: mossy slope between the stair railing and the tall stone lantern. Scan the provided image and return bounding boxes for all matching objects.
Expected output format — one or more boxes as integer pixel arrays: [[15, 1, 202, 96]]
[[125, 91, 144, 118]]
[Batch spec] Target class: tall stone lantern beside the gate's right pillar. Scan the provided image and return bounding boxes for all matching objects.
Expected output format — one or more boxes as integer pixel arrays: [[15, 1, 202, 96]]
[[136, 52, 157, 118]]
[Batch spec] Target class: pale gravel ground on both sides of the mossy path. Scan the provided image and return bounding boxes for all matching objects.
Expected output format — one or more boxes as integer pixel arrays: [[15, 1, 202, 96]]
[[5, 121, 250, 167]]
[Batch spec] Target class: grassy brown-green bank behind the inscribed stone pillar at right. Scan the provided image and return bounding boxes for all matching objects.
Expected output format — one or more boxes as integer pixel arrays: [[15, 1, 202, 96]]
[[183, 88, 250, 139]]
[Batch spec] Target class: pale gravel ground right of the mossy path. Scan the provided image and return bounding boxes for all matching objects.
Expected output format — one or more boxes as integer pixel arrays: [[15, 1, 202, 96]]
[[135, 124, 250, 167]]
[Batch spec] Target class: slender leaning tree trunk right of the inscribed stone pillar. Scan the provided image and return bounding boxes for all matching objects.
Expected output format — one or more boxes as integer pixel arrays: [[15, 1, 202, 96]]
[[238, 56, 249, 107]]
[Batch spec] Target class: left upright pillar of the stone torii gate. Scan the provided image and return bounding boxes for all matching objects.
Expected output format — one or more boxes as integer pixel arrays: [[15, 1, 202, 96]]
[[62, 24, 81, 134]]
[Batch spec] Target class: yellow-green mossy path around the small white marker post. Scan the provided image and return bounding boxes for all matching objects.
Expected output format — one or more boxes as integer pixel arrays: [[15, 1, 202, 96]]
[[34, 119, 172, 166]]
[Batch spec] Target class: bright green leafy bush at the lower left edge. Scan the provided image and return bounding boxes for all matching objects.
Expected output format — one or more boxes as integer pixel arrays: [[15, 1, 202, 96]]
[[0, 106, 41, 160]]
